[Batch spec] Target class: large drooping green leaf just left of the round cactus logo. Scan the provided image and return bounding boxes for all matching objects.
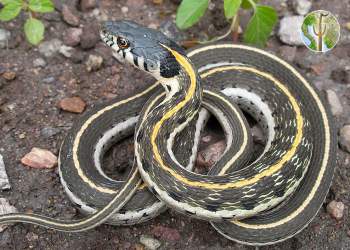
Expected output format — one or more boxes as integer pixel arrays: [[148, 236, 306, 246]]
[[243, 5, 277, 47]]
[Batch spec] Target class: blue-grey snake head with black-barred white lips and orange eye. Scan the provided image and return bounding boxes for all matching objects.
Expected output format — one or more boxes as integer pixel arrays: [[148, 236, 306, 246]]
[[100, 20, 185, 80]]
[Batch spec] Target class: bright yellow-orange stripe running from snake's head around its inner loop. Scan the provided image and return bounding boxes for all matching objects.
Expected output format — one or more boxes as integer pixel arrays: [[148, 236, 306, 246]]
[[151, 63, 303, 189]]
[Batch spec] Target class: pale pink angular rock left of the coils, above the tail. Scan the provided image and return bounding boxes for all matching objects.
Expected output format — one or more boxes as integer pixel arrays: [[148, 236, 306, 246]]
[[21, 148, 57, 168]]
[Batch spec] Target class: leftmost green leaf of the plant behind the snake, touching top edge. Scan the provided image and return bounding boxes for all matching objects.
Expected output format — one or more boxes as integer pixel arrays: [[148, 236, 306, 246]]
[[176, 0, 209, 29]]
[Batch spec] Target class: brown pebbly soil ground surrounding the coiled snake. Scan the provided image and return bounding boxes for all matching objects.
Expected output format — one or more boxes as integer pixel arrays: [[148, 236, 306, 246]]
[[0, 0, 350, 249]]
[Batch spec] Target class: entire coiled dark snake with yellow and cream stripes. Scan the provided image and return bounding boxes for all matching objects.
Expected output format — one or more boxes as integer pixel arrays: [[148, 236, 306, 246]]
[[0, 21, 336, 245]]
